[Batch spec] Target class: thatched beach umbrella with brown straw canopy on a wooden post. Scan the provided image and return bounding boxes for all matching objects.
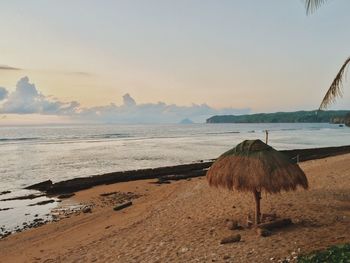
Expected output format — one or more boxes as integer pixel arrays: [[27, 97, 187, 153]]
[[207, 140, 308, 224]]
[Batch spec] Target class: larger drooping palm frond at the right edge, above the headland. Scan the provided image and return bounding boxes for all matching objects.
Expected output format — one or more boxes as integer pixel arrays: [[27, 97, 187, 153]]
[[319, 57, 350, 110]]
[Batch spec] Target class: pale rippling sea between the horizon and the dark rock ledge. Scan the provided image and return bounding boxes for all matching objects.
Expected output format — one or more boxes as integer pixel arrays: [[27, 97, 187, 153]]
[[0, 123, 350, 236]]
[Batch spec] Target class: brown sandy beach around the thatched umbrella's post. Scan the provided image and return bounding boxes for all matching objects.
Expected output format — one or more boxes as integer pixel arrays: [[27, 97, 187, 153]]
[[0, 154, 350, 262]]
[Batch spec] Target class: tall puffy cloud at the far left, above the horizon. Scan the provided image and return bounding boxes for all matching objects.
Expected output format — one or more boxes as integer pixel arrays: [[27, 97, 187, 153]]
[[0, 77, 79, 115]]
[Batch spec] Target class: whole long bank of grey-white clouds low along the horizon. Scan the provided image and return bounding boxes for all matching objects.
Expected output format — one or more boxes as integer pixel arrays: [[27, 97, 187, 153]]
[[0, 77, 250, 123]]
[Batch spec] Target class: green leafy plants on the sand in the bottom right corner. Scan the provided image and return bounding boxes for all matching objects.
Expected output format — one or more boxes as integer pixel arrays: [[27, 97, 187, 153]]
[[298, 243, 350, 263]]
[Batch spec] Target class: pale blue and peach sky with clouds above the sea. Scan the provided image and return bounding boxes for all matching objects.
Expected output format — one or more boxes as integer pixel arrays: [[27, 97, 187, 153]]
[[0, 0, 350, 125]]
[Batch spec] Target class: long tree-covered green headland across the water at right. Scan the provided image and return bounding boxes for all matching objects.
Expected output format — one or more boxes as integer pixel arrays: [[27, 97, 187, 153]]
[[207, 110, 350, 123]]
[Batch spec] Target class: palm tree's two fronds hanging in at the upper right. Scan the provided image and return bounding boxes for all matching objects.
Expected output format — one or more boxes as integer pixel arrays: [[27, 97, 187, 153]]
[[305, 0, 350, 110]]
